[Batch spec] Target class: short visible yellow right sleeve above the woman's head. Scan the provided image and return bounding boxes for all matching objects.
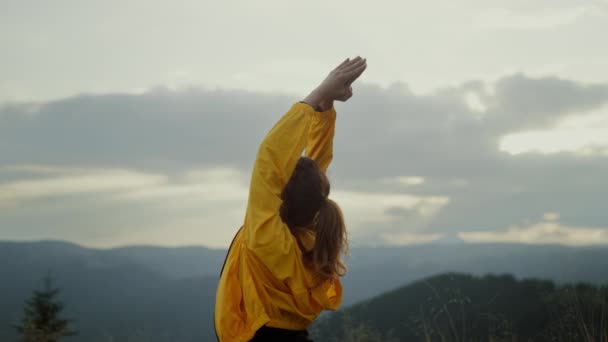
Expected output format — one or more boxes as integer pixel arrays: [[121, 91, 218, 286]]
[[306, 106, 336, 172]]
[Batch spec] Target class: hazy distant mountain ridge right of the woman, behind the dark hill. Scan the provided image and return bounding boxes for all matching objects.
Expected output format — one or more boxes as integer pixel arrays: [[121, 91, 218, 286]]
[[344, 244, 608, 305]]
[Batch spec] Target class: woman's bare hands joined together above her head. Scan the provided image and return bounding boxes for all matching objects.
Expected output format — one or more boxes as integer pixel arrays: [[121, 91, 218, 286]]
[[303, 57, 367, 108]]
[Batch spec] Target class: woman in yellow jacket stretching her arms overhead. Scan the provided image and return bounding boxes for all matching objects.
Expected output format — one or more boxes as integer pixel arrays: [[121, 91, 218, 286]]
[[215, 57, 367, 342]]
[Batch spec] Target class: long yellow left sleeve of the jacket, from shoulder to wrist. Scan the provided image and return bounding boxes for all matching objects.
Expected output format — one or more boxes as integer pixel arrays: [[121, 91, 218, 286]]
[[243, 102, 317, 278]]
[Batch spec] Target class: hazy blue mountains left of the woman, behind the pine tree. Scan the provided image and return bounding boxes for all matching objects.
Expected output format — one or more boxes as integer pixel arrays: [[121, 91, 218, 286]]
[[0, 241, 217, 342]]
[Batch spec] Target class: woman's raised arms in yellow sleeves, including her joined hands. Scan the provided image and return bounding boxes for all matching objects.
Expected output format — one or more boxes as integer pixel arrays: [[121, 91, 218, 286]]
[[244, 57, 366, 269]]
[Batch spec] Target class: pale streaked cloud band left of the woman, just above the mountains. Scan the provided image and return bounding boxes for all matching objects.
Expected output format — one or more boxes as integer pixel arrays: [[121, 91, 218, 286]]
[[0, 166, 248, 247]]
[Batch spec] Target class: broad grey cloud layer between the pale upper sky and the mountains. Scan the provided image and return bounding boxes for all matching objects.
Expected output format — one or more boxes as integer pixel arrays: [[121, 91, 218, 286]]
[[0, 74, 608, 246]]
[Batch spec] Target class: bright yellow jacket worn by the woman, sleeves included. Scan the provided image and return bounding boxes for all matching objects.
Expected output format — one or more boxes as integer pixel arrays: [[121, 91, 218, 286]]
[[215, 102, 342, 342]]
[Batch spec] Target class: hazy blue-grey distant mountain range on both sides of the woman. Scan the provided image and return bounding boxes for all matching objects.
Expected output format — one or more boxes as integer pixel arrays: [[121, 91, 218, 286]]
[[0, 241, 608, 342]]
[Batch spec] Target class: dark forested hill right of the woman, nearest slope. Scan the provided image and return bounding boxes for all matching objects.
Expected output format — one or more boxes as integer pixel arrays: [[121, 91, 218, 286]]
[[310, 273, 608, 342]]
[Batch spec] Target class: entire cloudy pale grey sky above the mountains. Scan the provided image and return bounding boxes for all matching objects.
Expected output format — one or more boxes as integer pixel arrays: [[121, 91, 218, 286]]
[[0, 0, 608, 247]]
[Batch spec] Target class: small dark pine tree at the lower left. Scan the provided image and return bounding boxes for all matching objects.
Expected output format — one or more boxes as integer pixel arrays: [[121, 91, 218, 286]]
[[14, 274, 76, 342]]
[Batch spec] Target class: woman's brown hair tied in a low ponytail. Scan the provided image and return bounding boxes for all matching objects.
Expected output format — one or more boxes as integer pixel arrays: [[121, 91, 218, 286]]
[[280, 157, 348, 279]]
